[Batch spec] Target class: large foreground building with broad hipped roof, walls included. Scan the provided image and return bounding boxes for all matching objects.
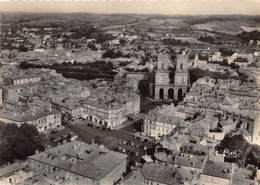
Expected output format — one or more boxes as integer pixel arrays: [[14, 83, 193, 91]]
[[28, 141, 127, 185]]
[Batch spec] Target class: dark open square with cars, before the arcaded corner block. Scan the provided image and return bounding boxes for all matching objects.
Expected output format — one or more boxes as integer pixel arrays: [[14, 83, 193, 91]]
[[62, 118, 155, 162]]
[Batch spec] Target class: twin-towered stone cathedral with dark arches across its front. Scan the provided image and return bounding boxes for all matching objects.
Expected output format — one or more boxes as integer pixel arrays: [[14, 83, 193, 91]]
[[150, 52, 190, 100]]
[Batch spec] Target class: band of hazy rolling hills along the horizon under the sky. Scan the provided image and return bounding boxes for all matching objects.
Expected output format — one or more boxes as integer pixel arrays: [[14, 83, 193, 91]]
[[2, 13, 260, 34]]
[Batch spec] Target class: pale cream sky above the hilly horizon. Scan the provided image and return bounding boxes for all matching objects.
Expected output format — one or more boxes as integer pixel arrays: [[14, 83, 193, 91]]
[[0, 0, 260, 15]]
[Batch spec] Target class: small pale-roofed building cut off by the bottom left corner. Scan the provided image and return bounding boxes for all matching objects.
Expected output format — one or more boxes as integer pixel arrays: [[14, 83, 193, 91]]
[[0, 163, 33, 185]]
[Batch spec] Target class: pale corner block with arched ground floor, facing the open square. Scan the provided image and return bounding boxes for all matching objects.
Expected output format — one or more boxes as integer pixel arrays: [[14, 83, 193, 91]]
[[83, 92, 140, 129]]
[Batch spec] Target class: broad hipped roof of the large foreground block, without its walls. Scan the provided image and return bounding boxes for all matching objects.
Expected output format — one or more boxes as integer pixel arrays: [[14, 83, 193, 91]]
[[29, 141, 127, 180]]
